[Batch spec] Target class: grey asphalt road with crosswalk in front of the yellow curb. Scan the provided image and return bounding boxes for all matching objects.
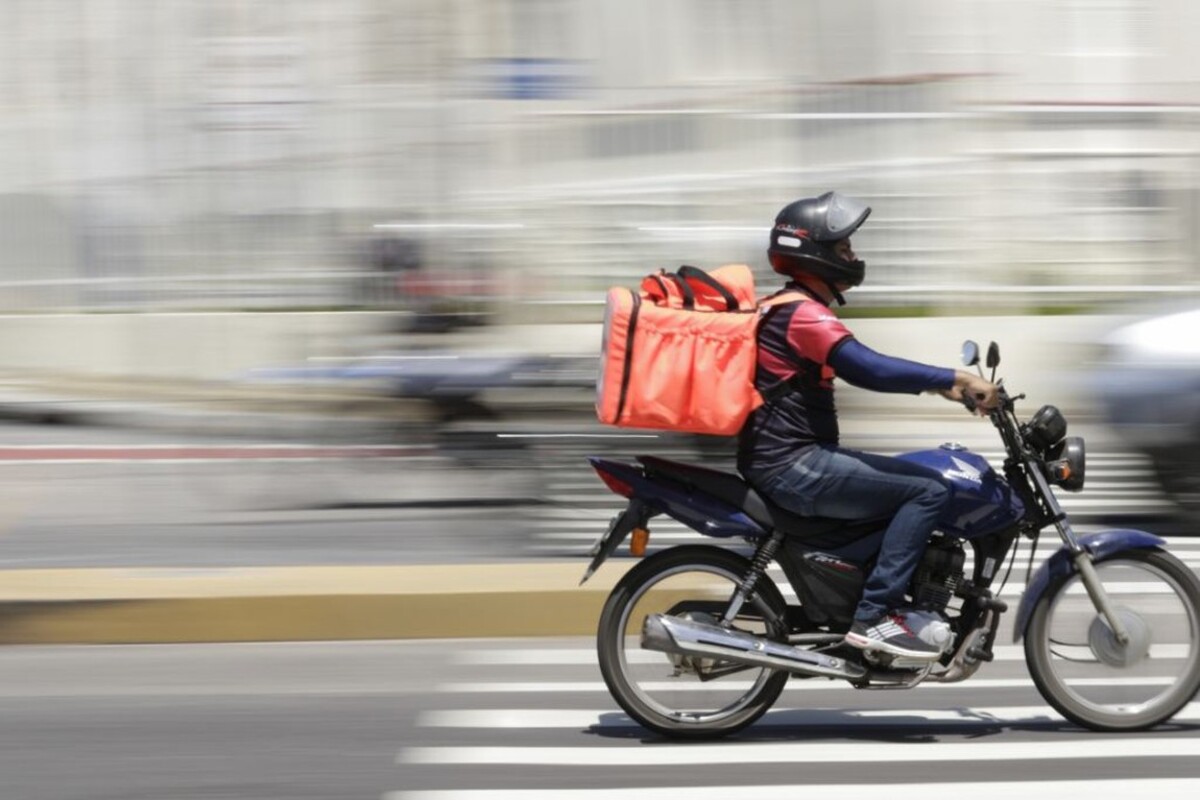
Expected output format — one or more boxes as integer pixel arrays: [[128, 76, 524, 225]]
[[0, 638, 1200, 800]]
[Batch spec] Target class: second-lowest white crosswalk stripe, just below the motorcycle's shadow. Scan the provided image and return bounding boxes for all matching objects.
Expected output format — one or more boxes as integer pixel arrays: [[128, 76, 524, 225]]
[[396, 736, 1200, 767]]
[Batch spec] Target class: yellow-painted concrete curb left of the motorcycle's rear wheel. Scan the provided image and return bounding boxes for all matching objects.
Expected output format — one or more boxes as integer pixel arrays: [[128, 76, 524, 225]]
[[0, 560, 631, 644]]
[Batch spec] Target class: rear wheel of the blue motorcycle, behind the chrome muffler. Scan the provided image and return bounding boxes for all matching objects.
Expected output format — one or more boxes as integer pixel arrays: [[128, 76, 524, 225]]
[[596, 546, 788, 739]]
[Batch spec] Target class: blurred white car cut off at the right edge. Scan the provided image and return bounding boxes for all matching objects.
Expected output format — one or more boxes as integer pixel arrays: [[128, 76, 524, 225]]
[[1096, 303, 1200, 512]]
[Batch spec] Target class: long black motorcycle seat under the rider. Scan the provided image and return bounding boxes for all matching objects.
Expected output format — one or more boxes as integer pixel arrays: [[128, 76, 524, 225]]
[[637, 456, 882, 546]]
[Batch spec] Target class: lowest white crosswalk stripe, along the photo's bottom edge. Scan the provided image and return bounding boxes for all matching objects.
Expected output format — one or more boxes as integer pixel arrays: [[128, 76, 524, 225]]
[[383, 778, 1200, 800]]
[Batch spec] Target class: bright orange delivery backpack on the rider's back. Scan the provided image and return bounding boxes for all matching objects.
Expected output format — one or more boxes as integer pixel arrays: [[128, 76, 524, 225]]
[[595, 264, 805, 435]]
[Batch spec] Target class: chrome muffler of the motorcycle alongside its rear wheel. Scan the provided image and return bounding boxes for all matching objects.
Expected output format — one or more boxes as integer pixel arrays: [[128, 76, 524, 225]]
[[642, 614, 866, 680]]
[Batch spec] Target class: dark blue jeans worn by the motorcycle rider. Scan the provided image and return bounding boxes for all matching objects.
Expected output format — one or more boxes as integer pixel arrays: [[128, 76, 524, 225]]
[[745, 445, 952, 621]]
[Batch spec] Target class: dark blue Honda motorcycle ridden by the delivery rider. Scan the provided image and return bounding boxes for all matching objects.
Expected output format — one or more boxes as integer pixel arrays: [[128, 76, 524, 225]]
[[581, 342, 1200, 739]]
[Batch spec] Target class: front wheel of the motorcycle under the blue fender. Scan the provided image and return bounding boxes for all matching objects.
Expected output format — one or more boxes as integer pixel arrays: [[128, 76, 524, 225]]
[[1025, 549, 1200, 730]]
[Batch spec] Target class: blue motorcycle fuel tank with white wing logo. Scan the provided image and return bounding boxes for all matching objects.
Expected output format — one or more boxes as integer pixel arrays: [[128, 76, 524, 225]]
[[900, 444, 1025, 539]]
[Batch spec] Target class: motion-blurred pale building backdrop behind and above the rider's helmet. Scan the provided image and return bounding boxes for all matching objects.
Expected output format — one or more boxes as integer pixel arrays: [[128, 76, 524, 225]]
[[0, 0, 1200, 321]]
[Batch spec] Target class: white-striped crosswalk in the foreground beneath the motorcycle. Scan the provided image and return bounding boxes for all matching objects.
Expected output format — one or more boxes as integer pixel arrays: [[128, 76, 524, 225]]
[[383, 639, 1200, 800]]
